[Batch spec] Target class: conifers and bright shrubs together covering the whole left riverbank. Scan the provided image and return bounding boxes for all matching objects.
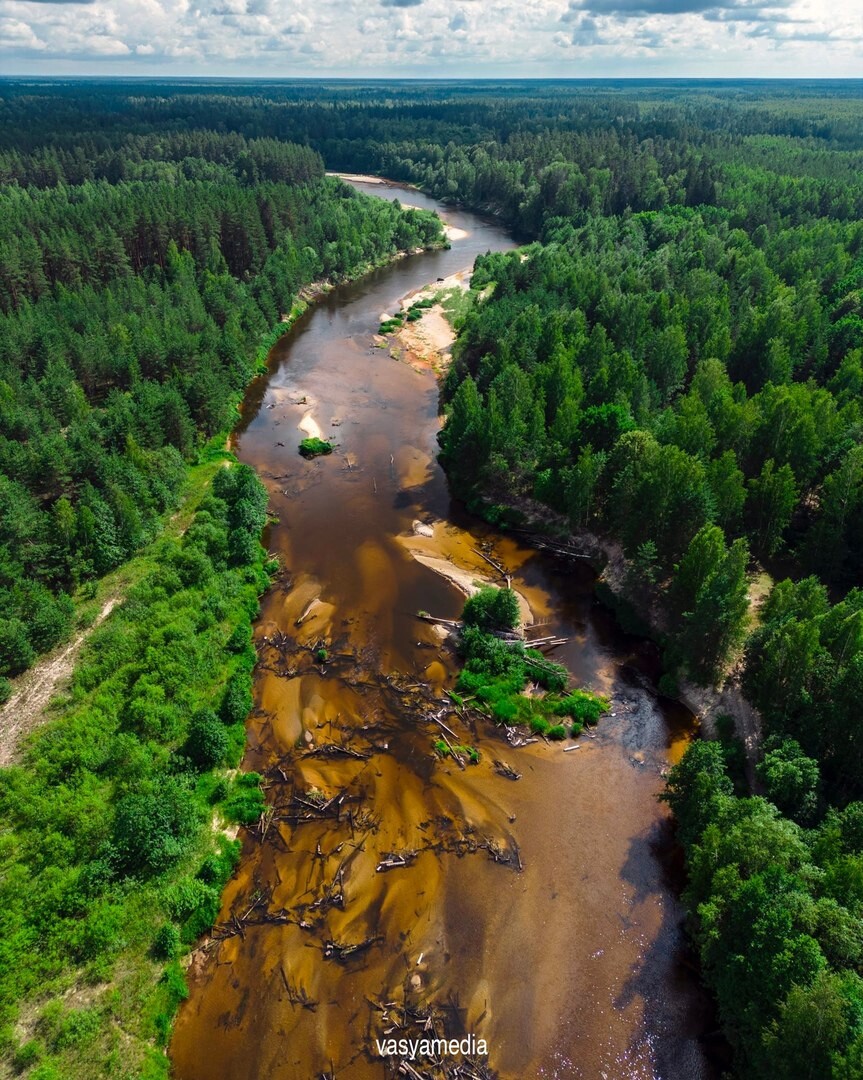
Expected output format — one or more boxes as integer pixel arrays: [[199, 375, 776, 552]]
[[0, 79, 444, 1080]]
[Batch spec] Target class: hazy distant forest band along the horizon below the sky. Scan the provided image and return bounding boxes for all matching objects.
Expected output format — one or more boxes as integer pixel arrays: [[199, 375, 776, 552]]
[[6, 82, 863, 235]]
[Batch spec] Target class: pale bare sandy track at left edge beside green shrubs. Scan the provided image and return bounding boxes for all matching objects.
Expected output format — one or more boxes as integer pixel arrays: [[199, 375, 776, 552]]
[[0, 596, 119, 766]]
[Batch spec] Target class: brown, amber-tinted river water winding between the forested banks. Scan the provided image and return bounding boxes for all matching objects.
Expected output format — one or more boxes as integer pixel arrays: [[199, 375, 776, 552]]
[[172, 181, 713, 1080]]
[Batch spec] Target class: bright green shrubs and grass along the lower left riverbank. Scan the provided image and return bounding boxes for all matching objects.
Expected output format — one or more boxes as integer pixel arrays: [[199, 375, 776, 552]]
[[0, 204, 457, 1080]]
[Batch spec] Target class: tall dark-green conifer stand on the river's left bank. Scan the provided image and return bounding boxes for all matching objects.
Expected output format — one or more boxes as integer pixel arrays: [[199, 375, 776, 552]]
[[0, 120, 441, 682]]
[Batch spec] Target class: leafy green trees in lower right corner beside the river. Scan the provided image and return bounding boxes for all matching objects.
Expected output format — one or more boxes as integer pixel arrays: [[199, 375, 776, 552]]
[[663, 578, 863, 1080]]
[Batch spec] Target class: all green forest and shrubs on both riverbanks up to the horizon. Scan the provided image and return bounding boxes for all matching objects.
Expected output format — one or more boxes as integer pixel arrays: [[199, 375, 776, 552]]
[[0, 81, 863, 1080]]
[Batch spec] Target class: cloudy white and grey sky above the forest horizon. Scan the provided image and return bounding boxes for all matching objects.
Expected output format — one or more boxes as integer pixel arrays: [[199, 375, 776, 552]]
[[0, 0, 863, 79]]
